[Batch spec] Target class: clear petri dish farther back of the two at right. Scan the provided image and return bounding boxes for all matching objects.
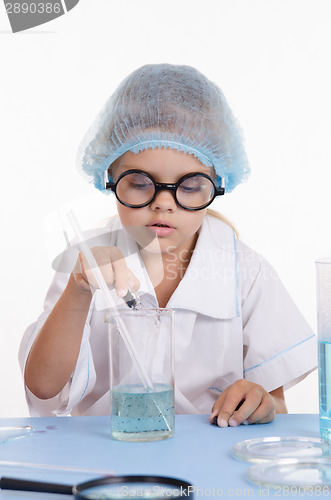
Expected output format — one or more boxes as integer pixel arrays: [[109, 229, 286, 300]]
[[232, 437, 331, 463]]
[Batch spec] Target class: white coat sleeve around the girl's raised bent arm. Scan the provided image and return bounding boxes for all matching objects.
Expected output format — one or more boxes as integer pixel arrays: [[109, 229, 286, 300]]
[[19, 273, 96, 417]]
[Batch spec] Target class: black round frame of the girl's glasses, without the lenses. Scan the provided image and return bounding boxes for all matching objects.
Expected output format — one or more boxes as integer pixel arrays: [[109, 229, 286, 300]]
[[105, 168, 225, 212]]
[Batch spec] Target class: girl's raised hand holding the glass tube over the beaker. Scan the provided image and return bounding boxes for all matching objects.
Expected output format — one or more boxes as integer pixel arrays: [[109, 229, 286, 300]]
[[72, 247, 140, 297]]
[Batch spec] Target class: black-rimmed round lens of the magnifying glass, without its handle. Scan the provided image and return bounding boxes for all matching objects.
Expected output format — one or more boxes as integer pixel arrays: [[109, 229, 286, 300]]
[[73, 476, 194, 500]]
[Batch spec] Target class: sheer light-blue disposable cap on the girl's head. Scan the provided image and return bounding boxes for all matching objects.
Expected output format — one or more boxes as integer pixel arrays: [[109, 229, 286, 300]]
[[78, 64, 250, 192]]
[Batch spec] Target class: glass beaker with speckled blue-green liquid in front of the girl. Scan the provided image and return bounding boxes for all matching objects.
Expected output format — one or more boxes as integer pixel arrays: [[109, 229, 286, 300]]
[[106, 308, 175, 441]]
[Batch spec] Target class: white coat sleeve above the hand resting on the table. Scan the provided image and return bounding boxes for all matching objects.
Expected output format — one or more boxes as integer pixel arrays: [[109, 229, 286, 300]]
[[242, 257, 317, 392]]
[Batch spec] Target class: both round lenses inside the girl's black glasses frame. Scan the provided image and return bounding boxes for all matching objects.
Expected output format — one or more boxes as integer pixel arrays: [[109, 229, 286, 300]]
[[116, 172, 215, 208]]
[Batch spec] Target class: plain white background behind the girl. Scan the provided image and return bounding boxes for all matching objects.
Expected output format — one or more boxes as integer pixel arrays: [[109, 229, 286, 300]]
[[0, 0, 331, 417]]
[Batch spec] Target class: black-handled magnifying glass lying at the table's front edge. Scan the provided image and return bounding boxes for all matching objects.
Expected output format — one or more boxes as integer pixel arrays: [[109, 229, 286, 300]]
[[0, 475, 194, 500]]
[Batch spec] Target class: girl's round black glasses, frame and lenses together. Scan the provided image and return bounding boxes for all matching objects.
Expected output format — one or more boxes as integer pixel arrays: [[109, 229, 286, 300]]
[[106, 169, 224, 210]]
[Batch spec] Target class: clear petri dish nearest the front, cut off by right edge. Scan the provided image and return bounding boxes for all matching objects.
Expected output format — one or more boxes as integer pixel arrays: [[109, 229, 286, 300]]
[[248, 458, 331, 488]]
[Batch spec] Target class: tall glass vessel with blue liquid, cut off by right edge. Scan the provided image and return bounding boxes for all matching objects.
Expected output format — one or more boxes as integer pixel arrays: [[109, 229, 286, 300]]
[[316, 258, 331, 440]]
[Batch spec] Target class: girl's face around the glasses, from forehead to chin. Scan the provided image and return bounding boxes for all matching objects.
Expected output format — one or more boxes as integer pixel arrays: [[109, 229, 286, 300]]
[[111, 148, 215, 254]]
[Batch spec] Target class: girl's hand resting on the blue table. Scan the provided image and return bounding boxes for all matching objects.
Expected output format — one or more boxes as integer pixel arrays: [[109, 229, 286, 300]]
[[209, 379, 286, 427]]
